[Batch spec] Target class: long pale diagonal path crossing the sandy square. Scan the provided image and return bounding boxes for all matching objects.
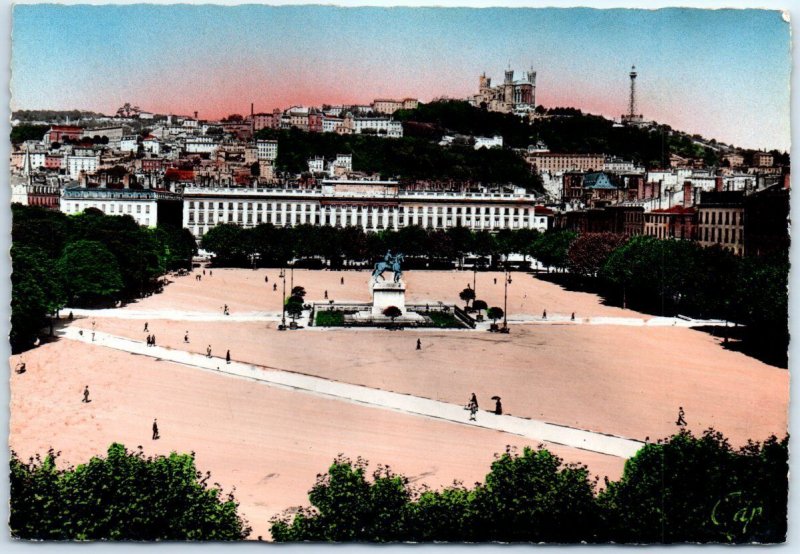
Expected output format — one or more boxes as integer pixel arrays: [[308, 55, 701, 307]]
[[59, 324, 644, 458]]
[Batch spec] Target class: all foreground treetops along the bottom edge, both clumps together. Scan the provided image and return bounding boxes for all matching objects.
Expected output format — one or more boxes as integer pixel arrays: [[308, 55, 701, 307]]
[[9, 429, 789, 543]]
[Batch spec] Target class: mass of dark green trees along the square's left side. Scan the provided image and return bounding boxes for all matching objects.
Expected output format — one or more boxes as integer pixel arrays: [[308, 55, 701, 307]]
[[10, 204, 197, 352]]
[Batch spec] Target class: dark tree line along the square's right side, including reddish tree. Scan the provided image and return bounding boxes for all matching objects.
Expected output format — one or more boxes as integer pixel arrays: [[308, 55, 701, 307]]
[[552, 231, 789, 367]]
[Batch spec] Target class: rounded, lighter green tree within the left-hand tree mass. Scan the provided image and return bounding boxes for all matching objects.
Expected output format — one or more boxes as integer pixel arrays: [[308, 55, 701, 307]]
[[56, 240, 122, 307]]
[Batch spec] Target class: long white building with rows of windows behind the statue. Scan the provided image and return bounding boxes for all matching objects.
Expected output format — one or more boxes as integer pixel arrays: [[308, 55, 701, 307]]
[[183, 180, 552, 239]]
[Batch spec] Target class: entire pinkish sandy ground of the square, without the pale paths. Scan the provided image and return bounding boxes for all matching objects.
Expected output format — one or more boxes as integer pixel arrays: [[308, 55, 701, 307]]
[[10, 269, 789, 536]]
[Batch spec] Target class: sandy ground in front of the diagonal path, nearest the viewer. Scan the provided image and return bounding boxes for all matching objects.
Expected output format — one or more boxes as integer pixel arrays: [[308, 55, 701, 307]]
[[10, 340, 624, 538]]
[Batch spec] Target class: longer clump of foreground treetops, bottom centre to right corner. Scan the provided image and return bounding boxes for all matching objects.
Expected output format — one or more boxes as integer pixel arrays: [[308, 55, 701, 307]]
[[271, 430, 788, 543]]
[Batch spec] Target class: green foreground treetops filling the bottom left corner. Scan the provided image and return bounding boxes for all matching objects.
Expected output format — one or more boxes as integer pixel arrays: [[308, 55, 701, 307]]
[[9, 443, 250, 541]]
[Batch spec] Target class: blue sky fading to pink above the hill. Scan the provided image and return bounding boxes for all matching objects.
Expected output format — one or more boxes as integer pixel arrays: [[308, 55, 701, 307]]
[[11, 4, 791, 150]]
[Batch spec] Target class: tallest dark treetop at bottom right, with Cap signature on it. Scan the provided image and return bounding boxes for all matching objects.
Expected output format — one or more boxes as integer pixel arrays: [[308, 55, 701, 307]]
[[598, 430, 789, 543]]
